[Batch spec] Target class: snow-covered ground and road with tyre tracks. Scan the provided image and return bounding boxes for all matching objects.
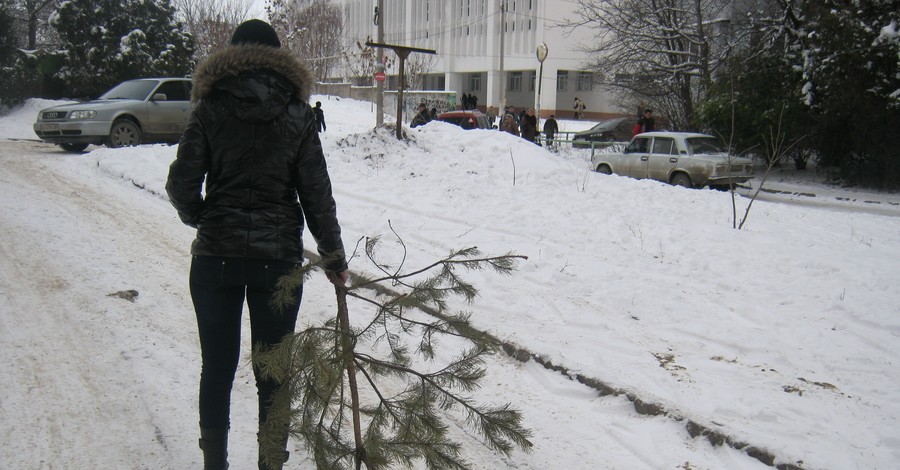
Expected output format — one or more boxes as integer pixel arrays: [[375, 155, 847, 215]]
[[0, 96, 900, 469]]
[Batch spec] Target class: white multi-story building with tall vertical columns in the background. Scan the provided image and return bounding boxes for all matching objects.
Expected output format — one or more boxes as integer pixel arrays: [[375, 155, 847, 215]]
[[335, 0, 622, 119]]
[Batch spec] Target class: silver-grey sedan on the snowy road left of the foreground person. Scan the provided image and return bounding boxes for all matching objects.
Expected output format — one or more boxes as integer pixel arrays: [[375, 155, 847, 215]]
[[34, 78, 191, 152]]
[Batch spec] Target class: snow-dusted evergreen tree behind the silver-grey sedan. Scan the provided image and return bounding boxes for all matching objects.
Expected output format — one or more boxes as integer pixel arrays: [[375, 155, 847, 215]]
[[52, 0, 194, 96]]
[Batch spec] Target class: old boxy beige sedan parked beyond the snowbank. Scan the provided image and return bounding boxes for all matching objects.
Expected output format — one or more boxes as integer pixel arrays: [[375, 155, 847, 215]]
[[591, 132, 753, 189]]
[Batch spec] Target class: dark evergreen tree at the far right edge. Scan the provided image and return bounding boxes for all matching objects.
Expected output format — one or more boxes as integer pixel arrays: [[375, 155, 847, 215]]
[[782, 0, 900, 188]]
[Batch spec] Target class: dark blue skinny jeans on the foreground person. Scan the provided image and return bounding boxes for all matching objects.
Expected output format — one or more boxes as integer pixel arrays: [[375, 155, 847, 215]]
[[190, 256, 303, 428]]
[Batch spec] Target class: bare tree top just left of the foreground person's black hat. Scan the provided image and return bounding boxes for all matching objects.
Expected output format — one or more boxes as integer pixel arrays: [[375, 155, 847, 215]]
[[173, 0, 253, 62]]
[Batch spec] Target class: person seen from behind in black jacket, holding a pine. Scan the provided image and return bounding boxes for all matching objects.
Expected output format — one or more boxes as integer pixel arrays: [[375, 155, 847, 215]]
[[166, 20, 348, 470]]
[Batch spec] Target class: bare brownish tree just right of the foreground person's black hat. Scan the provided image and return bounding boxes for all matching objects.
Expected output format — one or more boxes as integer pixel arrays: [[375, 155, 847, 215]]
[[266, 0, 344, 81]]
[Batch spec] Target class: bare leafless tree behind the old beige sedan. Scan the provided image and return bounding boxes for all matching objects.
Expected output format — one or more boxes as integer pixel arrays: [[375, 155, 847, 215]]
[[566, 0, 771, 129]]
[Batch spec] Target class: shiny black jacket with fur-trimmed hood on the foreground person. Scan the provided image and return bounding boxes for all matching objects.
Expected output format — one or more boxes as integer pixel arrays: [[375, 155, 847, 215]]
[[166, 44, 347, 272]]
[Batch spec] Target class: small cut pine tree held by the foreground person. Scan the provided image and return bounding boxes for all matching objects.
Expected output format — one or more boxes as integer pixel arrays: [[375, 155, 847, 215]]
[[254, 239, 531, 470]]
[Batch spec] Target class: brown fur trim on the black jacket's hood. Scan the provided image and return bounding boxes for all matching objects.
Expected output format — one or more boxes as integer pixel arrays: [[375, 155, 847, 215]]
[[191, 44, 314, 103]]
